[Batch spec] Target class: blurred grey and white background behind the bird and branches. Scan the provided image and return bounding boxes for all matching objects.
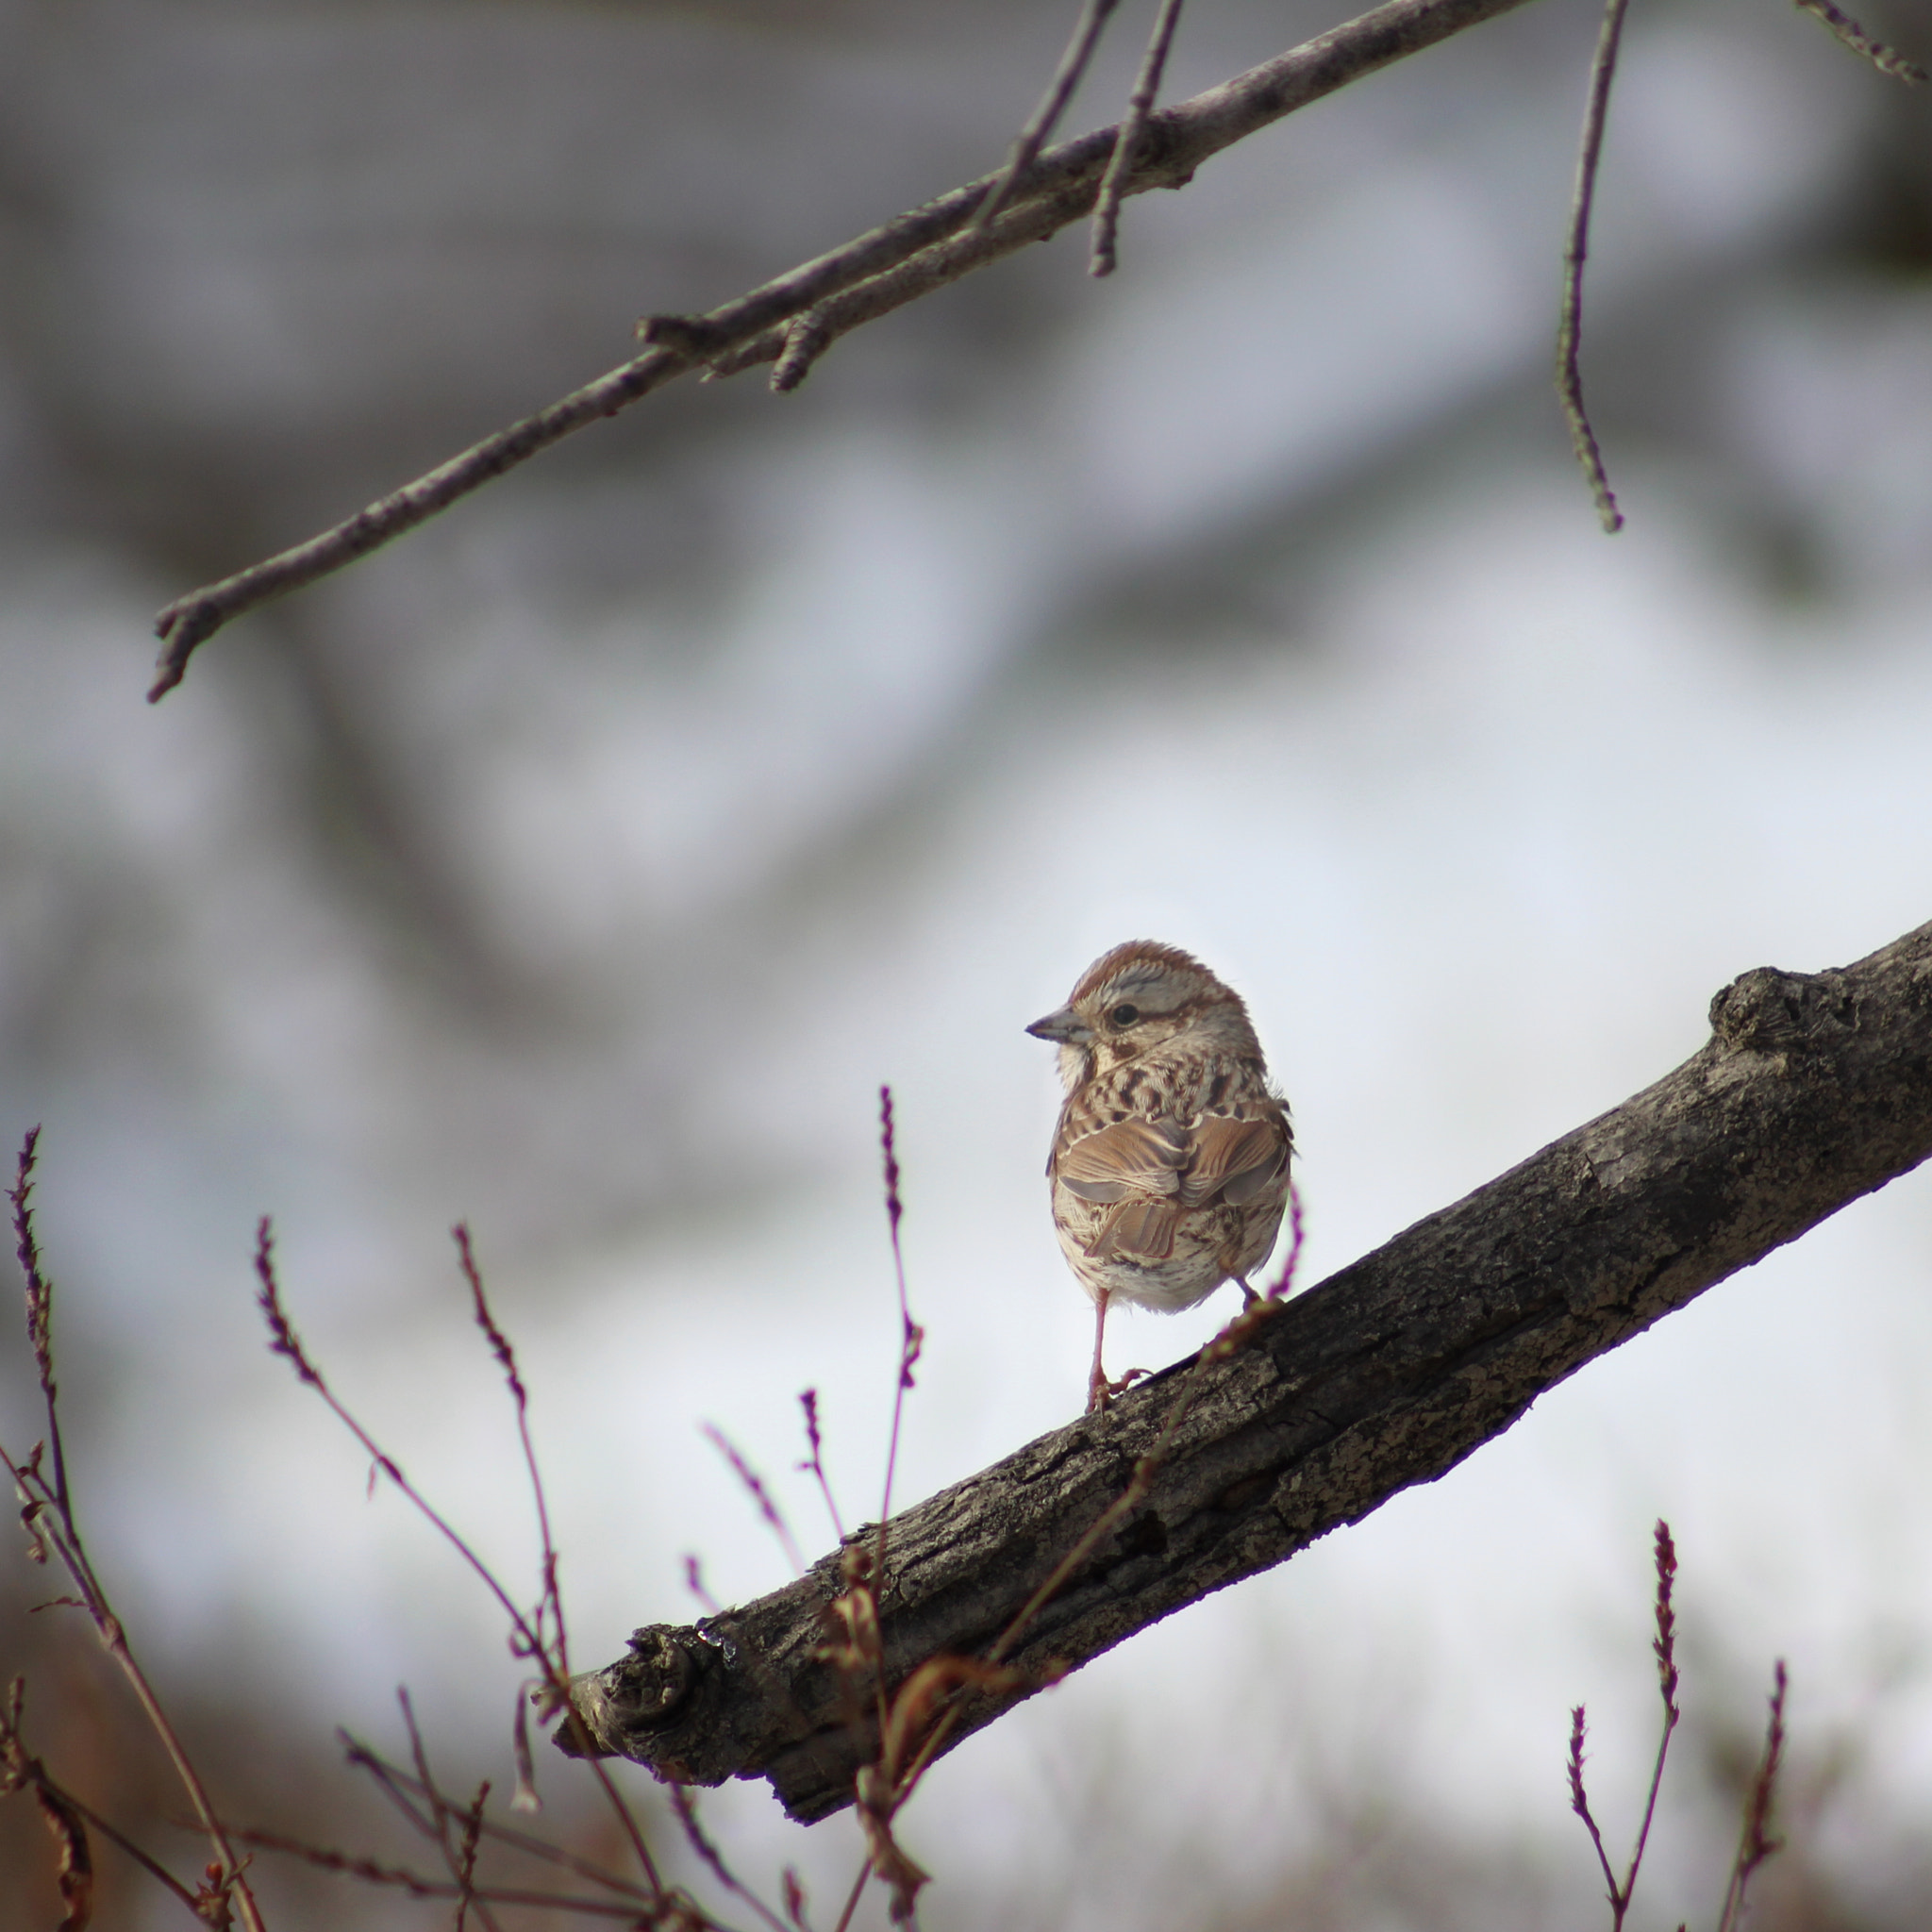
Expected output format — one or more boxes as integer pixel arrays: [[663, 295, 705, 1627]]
[[0, 0, 1932, 1932]]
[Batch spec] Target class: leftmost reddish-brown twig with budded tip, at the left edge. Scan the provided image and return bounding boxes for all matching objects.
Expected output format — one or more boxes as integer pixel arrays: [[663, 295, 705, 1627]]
[[0, 1128, 263, 1932]]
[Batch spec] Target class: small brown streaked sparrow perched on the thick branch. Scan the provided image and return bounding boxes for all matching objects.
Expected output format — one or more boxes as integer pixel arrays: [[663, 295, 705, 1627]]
[[1025, 939, 1294, 1414]]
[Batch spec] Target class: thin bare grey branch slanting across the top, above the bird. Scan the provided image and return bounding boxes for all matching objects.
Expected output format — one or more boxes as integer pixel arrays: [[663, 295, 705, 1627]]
[[147, 0, 1526, 703]]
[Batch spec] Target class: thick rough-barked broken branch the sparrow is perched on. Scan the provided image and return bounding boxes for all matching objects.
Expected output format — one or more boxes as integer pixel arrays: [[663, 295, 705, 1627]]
[[559, 925, 1932, 1820]]
